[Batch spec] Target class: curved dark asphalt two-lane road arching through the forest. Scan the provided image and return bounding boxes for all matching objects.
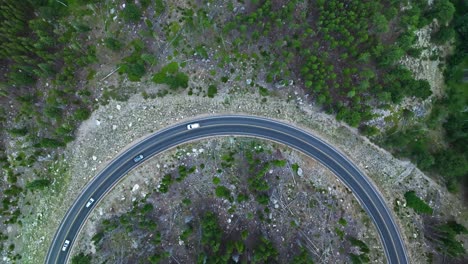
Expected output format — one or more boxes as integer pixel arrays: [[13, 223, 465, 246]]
[[45, 115, 408, 264]]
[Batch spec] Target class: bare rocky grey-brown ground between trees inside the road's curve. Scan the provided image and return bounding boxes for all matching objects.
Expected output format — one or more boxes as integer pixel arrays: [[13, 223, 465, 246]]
[[75, 138, 385, 263]]
